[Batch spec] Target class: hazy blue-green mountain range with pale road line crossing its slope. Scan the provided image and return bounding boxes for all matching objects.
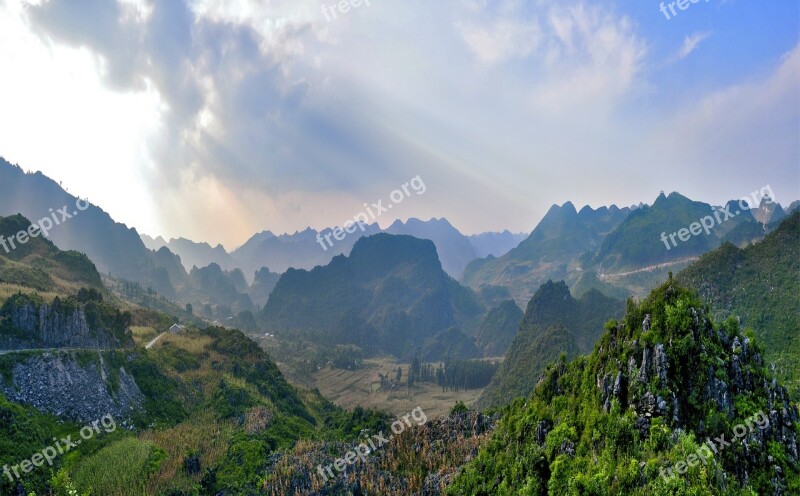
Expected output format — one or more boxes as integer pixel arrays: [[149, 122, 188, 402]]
[[463, 193, 798, 304]]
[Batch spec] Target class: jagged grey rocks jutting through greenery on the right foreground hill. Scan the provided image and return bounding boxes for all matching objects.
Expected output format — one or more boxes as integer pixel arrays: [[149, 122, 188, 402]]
[[596, 298, 800, 494]]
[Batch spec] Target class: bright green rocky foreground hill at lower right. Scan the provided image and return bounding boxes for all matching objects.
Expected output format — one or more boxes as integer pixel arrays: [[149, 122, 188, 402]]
[[448, 281, 800, 496]]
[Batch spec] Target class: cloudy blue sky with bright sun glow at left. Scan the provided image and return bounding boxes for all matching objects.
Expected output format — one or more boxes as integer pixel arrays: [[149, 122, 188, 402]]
[[0, 0, 800, 249]]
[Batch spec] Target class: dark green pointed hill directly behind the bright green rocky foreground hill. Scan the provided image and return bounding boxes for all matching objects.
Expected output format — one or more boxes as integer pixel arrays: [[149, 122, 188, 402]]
[[476, 281, 625, 408]]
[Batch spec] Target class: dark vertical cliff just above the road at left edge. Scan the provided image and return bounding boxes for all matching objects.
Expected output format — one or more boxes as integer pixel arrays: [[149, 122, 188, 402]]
[[0, 295, 133, 350]]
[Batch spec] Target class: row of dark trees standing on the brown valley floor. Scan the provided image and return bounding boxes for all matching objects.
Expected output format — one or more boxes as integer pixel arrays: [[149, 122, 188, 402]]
[[410, 357, 499, 391]]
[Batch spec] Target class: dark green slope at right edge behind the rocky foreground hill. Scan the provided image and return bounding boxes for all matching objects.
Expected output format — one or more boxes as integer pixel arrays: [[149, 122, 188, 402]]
[[677, 212, 800, 395]]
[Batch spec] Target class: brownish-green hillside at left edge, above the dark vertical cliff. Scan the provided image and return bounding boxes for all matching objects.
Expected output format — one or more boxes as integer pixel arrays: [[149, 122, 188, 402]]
[[0, 214, 105, 294]]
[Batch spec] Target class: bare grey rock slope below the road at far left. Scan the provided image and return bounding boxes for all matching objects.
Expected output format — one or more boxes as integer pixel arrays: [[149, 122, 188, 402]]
[[0, 352, 144, 425]]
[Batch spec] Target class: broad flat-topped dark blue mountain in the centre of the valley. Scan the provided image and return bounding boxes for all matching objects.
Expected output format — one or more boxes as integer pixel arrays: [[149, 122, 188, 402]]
[[260, 233, 483, 357]]
